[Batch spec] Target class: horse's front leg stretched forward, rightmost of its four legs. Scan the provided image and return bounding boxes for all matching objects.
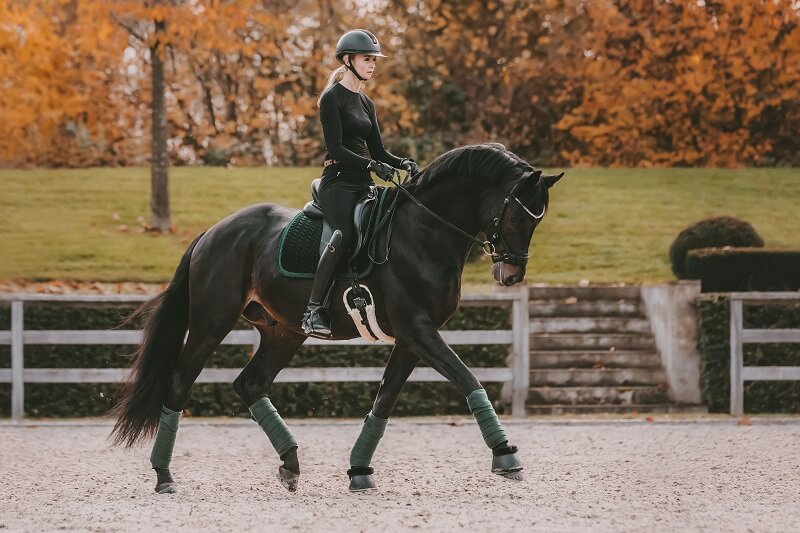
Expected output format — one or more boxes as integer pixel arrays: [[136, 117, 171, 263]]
[[400, 322, 522, 480]]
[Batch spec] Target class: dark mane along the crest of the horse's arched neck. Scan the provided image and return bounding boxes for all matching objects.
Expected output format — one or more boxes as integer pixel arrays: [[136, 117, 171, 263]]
[[406, 143, 533, 193]]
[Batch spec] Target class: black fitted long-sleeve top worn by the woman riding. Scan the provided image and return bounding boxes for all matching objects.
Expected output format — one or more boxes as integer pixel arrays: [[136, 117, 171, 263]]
[[319, 83, 401, 170]]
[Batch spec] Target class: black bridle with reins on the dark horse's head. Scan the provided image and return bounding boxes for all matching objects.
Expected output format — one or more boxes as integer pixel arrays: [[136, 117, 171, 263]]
[[375, 170, 546, 267]]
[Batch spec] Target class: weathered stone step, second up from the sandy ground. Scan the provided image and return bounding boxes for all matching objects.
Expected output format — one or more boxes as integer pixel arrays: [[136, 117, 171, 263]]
[[528, 386, 668, 405]]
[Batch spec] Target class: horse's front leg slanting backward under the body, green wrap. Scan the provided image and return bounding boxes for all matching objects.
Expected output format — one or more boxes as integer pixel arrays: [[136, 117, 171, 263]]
[[347, 342, 419, 492]]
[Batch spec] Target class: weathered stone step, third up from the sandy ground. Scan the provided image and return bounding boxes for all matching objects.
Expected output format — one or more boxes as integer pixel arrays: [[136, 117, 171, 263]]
[[530, 368, 667, 387]]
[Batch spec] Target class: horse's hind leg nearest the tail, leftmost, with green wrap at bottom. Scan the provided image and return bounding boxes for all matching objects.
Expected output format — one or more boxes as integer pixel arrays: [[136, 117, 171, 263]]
[[150, 295, 242, 494]]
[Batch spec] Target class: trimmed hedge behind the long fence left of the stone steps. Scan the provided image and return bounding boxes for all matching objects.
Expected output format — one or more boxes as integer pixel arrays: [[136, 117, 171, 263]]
[[0, 303, 510, 418]]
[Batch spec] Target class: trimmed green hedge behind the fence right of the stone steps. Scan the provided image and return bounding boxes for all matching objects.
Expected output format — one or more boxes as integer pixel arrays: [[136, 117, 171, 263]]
[[695, 295, 800, 413]]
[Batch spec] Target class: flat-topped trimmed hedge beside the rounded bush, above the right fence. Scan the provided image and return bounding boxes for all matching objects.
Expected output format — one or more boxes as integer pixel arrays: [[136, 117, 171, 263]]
[[686, 248, 800, 292]]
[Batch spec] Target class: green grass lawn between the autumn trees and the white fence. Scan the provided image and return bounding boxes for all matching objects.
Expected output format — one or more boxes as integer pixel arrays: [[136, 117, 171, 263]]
[[0, 167, 800, 285]]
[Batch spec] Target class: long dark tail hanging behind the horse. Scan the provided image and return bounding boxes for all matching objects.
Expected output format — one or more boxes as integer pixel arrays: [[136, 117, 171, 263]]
[[111, 233, 203, 447]]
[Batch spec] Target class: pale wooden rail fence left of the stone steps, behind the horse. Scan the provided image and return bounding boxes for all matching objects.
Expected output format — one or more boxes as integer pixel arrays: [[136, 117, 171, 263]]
[[0, 286, 530, 420]]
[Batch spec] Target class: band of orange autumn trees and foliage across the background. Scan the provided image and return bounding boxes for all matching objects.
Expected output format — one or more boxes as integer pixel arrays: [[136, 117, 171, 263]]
[[0, 0, 800, 167]]
